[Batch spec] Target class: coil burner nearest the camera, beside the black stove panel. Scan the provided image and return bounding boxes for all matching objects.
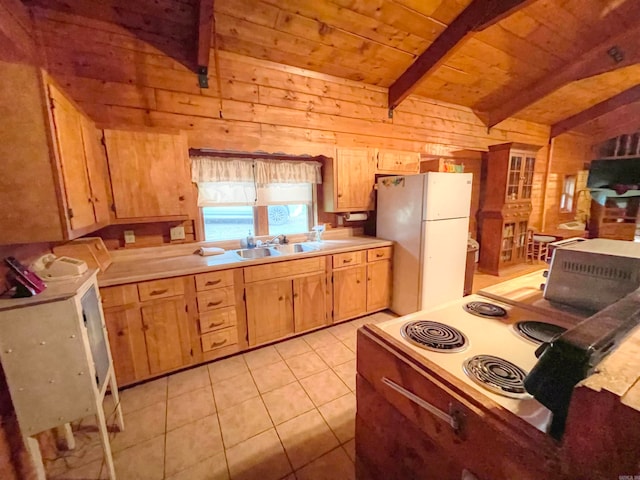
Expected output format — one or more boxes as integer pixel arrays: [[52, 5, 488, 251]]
[[462, 355, 531, 398]]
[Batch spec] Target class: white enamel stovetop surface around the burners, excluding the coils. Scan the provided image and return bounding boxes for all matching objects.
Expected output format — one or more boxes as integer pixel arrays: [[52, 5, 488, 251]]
[[378, 295, 557, 431]]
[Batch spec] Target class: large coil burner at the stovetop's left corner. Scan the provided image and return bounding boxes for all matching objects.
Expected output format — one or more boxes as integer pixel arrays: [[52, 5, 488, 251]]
[[400, 320, 468, 353]]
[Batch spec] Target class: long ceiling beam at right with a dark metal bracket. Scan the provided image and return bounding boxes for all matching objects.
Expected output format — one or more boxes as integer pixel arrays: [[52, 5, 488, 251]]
[[486, 25, 640, 128]]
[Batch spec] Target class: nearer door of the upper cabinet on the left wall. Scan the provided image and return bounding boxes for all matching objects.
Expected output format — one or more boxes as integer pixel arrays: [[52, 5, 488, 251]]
[[49, 85, 95, 230]]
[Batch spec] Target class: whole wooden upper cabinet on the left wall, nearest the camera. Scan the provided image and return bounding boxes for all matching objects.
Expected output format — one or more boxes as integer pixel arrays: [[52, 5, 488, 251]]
[[0, 62, 108, 244]]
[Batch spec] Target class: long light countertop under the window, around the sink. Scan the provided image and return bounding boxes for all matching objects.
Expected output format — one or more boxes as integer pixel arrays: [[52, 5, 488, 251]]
[[98, 236, 393, 287]]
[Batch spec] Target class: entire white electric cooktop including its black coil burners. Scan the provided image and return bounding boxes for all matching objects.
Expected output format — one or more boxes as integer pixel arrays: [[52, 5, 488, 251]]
[[377, 295, 570, 432]]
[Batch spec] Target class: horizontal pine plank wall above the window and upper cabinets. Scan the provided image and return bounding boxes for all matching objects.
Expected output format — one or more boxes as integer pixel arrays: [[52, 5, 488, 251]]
[[28, 0, 564, 240]]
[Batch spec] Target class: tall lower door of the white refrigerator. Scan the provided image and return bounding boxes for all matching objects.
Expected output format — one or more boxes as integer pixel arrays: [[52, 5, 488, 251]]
[[420, 217, 469, 310]]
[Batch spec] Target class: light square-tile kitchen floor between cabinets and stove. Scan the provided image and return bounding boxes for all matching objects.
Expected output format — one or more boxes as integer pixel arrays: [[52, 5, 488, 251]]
[[46, 312, 394, 480]]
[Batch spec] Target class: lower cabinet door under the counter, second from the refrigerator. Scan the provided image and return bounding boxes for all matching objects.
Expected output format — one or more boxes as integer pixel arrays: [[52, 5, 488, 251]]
[[333, 265, 367, 321]]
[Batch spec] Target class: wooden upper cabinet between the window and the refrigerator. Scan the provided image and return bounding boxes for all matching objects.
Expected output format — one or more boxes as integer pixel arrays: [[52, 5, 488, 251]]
[[323, 148, 375, 212]]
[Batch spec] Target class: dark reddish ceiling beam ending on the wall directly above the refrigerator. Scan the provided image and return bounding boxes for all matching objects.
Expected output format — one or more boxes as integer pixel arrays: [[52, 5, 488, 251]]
[[389, 0, 534, 109]]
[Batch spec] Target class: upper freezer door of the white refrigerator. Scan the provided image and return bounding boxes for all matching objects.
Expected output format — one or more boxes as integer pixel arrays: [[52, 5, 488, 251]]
[[422, 172, 473, 221]]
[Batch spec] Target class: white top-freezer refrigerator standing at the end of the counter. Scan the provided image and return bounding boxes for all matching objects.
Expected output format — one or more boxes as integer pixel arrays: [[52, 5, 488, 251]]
[[376, 172, 473, 315]]
